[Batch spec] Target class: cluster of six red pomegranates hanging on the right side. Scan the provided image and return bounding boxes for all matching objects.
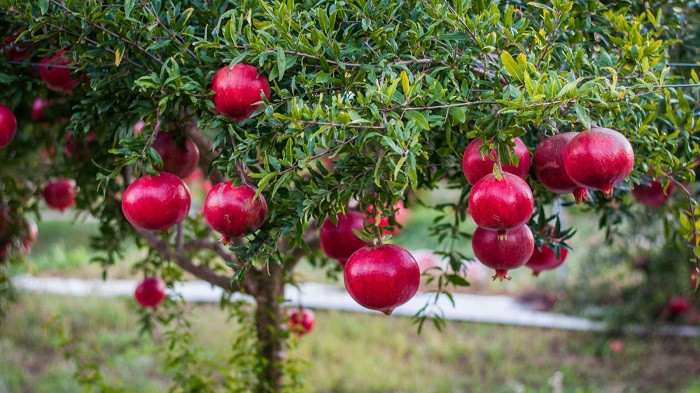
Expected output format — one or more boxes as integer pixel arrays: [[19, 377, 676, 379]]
[[462, 127, 636, 280]]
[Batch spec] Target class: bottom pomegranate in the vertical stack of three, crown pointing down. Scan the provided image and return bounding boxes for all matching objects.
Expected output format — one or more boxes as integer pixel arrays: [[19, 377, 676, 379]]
[[472, 225, 535, 281]]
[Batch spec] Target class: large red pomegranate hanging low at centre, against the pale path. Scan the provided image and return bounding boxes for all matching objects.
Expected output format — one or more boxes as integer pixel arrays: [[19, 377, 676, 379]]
[[343, 244, 420, 315]]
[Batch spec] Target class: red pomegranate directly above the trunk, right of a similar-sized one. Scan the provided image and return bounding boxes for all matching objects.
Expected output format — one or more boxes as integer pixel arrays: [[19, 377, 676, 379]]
[[204, 182, 267, 243]]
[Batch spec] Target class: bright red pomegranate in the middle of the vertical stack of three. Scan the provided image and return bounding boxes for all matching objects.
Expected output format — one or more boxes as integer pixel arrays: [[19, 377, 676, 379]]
[[469, 172, 535, 231]]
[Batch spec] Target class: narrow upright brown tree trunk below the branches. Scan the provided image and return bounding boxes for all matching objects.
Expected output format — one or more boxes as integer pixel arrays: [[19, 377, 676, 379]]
[[255, 263, 286, 393]]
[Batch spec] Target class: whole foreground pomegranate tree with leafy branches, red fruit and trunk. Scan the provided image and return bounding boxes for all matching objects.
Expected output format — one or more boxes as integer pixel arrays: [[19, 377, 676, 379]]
[[0, 0, 700, 393]]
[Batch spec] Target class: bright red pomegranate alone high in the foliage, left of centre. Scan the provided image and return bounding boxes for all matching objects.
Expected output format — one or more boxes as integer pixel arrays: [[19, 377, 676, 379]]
[[211, 64, 270, 121]]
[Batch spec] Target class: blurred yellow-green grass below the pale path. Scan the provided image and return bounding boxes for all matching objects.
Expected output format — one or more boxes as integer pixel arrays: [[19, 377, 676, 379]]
[[0, 294, 700, 393]]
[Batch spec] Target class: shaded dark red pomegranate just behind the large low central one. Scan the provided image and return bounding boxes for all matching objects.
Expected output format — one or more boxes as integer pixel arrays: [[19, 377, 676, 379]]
[[319, 211, 370, 265]]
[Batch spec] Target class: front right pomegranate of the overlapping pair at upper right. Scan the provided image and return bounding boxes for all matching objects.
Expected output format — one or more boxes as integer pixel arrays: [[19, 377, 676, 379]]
[[564, 127, 634, 196]]
